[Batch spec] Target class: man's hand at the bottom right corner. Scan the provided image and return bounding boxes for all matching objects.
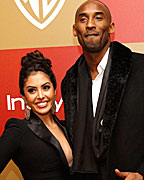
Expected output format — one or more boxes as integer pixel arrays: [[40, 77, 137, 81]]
[[115, 169, 143, 180]]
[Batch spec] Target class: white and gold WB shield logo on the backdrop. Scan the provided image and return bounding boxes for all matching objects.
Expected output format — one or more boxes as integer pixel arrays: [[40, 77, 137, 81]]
[[14, 0, 65, 29]]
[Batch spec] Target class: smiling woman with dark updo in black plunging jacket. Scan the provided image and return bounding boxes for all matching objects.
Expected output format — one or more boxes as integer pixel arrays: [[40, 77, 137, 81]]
[[0, 51, 72, 180]]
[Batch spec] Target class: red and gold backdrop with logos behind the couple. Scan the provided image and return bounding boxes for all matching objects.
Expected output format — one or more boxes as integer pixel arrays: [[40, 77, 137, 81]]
[[0, 0, 144, 180]]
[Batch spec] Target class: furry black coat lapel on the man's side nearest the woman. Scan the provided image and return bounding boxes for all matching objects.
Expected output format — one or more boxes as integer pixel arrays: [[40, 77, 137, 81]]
[[61, 55, 84, 142]]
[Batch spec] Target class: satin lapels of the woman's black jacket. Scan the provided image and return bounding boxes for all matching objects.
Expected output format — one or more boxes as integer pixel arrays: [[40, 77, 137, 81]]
[[27, 112, 68, 167]]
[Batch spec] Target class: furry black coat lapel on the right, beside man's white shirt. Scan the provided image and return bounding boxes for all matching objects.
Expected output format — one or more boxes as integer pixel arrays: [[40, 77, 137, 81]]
[[100, 42, 131, 154]]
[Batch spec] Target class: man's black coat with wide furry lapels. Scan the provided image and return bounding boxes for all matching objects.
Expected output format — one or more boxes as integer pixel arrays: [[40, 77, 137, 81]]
[[62, 42, 144, 180]]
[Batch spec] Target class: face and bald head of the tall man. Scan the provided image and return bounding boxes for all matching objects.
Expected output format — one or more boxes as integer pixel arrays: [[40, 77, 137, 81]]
[[73, 0, 114, 52]]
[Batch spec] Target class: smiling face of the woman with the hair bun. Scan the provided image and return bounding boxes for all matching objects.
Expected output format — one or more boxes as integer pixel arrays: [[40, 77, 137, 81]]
[[23, 71, 55, 116]]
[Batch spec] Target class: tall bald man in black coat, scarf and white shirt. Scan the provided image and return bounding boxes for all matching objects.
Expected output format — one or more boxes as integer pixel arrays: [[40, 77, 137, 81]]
[[62, 0, 144, 180]]
